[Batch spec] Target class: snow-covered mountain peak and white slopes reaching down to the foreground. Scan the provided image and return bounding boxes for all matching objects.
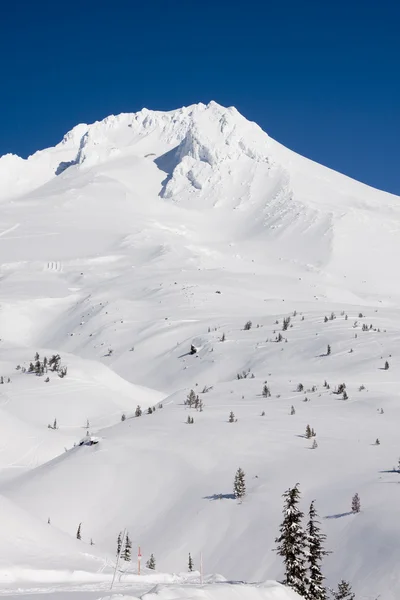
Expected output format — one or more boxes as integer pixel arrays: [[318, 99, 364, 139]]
[[0, 103, 400, 600]]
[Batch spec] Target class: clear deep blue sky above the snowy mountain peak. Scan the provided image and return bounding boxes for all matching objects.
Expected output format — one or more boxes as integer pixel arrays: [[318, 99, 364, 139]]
[[0, 0, 400, 194]]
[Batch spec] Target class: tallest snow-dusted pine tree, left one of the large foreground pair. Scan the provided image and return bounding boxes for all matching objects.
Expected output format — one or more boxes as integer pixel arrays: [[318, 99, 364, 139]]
[[275, 483, 308, 597]]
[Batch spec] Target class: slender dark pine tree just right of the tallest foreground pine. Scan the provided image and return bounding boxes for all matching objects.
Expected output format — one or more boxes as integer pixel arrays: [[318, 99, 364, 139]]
[[307, 500, 329, 600]]
